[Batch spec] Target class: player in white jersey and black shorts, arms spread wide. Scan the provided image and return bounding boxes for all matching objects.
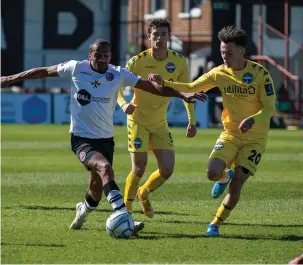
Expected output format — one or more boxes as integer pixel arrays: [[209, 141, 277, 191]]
[[1, 39, 201, 232]]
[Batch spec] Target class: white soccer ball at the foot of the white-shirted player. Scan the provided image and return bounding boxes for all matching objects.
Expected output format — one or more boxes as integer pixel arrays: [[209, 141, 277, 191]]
[[106, 211, 134, 238]]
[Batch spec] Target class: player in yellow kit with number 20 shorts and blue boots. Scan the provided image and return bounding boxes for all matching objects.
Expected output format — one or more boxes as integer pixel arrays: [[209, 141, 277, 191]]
[[149, 26, 276, 236]]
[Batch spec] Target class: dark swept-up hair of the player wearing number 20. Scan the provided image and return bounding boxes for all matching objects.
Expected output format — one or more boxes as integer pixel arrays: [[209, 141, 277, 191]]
[[218, 26, 248, 48]]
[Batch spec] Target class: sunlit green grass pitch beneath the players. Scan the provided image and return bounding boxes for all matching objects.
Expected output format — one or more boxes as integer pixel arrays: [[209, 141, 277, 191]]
[[1, 125, 303, 264]]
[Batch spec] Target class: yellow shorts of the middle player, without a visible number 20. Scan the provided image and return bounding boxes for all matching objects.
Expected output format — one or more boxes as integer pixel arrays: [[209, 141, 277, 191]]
[[127, 119, 174, 152]]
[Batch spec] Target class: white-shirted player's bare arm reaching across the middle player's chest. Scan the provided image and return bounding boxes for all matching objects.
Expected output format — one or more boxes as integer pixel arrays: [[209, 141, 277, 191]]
[[136, 78, 207, 103]]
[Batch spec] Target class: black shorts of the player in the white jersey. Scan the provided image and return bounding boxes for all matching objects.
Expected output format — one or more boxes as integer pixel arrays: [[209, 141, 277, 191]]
[[71, 134, 115, 170]]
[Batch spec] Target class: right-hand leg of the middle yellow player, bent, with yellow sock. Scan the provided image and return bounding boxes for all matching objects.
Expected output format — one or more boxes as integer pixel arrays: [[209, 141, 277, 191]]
[[138, 149, 175, 218]]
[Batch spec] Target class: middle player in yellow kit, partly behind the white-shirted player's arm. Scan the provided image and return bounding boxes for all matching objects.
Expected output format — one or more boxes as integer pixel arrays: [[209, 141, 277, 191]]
[[118, 19, 197, 218]]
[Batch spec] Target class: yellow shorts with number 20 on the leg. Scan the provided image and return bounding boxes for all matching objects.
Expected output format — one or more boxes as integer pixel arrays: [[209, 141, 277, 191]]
[[209, 132, 267, 175]]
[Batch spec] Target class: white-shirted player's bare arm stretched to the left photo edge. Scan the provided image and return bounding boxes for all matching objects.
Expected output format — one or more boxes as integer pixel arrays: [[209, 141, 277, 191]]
[[1, 65, 59, 87]]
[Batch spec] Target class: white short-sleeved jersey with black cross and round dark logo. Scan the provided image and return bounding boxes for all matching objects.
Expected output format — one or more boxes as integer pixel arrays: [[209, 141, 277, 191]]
[[57, 60, 140, 139]]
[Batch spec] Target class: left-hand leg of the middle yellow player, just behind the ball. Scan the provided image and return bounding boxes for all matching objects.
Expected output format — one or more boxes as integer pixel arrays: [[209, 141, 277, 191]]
[[124, 152, 147, 213]]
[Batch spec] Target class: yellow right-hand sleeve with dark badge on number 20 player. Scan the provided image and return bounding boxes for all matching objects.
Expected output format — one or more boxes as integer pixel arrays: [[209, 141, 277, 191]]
[[251, 70, 276, 123]]
